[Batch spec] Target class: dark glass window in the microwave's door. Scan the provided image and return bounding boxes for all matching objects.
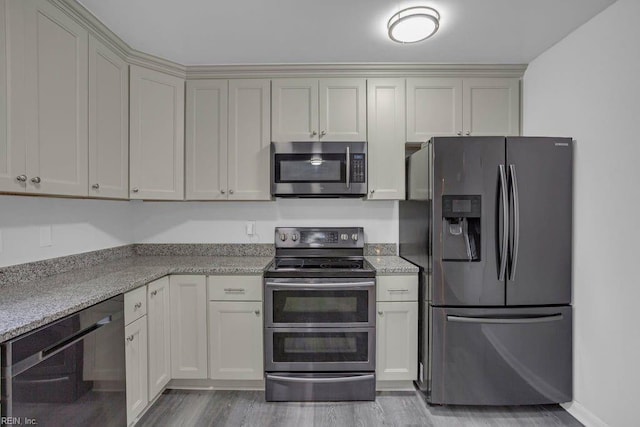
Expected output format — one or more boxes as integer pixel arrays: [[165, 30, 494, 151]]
[[276, 154, 346, 183]]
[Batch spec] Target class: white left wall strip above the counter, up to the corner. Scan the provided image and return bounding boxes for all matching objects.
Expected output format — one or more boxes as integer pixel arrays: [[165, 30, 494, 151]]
[[0, 195, 133, 267]]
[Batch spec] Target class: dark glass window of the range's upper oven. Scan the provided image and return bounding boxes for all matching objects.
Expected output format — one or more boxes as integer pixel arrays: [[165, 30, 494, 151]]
[[273, 290, 369, 323]]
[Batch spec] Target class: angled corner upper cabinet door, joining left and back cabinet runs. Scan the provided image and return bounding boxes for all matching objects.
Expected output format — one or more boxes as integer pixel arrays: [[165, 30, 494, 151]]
[[129, 65, 184, 200]]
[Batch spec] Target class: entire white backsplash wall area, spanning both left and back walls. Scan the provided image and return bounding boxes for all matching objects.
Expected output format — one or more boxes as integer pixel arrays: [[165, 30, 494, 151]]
[[0, 195, 398, 267]]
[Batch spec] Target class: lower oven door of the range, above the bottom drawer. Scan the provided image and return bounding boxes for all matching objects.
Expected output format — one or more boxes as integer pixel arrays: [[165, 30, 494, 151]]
[[265, 328, 376, 372]]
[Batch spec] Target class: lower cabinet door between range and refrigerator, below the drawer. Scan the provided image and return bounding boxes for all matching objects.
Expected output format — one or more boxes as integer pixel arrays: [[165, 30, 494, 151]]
[[376, 301, 418, 381]]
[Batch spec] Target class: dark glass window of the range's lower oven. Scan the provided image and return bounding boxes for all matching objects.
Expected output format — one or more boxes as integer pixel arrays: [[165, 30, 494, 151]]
[[273, 332, 369, 362]]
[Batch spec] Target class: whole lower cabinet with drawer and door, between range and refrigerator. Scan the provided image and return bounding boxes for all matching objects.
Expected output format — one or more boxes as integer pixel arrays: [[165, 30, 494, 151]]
[[376, 275, 418, 388]]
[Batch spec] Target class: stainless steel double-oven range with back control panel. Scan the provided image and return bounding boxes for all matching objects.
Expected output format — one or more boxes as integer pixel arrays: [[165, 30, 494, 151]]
[[264, 227, 376, 401]]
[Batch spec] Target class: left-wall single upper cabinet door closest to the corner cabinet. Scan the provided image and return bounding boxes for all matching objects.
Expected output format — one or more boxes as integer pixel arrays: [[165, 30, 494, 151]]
[[89, 36, 129, 199]]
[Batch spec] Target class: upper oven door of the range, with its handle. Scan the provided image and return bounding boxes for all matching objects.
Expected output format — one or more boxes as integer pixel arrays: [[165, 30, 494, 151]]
[[265, 279, 376, 328]]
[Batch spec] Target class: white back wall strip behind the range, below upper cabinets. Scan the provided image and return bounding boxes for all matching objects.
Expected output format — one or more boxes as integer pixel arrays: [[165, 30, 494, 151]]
[[134, 199, 398, 243]]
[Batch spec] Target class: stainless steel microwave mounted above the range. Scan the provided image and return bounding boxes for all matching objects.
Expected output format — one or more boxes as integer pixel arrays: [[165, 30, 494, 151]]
[[271, 142, 367, 197]]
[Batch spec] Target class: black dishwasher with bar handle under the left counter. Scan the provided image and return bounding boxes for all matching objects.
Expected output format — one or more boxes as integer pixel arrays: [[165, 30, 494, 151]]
[[1, 295, 127, 426]]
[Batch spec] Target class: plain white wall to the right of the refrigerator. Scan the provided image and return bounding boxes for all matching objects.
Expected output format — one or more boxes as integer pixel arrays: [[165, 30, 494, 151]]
[[523, 0, 640, 426]]
